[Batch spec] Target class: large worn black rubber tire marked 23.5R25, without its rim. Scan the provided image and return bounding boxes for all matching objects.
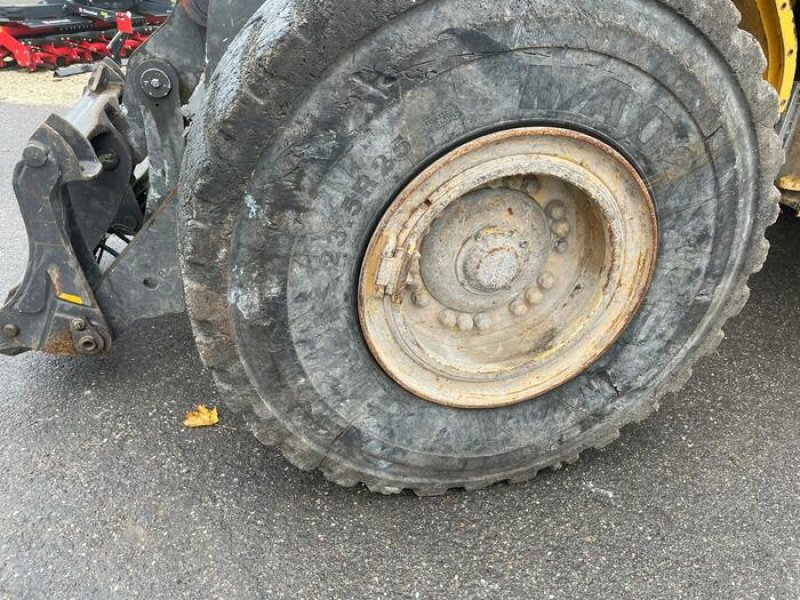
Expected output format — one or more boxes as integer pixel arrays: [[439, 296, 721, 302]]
[[182, 0, 781, 494]]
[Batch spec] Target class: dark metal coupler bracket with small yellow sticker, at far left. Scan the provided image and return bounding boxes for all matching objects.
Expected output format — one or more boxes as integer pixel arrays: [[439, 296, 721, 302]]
[[0, 63, 129, 354]]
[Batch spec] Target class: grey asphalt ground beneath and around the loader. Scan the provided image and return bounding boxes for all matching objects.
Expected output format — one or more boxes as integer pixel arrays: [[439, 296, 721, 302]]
[[0, 104, 800, 600]]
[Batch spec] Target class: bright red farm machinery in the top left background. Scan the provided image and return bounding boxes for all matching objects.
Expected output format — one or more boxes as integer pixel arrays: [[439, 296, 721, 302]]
[[0, 0, 173, 71]]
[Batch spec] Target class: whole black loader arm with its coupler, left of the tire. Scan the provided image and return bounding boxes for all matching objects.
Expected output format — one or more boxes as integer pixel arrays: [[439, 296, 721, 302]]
[[0, 0, 261, 355]]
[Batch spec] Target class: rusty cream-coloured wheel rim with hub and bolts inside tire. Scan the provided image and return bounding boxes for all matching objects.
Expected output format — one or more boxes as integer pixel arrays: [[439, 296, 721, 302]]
[[358, 128, 658, 409]]
